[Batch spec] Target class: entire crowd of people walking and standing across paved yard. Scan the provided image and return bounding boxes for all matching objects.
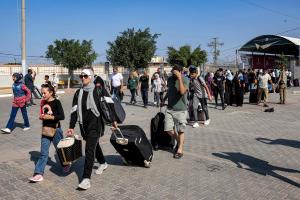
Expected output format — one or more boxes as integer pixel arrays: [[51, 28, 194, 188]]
[[1, 65, 289, 190]]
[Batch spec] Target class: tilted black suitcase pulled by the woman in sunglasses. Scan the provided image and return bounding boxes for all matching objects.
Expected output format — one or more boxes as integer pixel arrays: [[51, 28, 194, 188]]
[[110, 125, 153, 168]]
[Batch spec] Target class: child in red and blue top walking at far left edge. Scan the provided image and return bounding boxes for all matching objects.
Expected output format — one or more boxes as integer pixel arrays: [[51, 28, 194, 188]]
[[1, 73, 31, 133]]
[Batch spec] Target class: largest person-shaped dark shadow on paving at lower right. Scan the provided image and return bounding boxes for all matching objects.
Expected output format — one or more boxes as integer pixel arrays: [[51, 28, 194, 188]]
[[212, 152, 300, 187]]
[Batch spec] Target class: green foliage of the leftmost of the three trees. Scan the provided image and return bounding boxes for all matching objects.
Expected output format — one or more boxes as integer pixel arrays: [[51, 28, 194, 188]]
[[46, 39, 97, 73]]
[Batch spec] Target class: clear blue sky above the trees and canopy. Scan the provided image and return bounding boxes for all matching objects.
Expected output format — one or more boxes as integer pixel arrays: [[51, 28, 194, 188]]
[[0, 0, 300, 64]]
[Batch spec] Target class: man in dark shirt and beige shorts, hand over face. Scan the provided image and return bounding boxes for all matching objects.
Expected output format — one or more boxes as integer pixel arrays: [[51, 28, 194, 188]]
[[161, 65, 189, 159]]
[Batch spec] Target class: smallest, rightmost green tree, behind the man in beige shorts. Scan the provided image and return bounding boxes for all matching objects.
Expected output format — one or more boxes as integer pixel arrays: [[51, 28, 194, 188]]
[[168, 45, 207, 67]]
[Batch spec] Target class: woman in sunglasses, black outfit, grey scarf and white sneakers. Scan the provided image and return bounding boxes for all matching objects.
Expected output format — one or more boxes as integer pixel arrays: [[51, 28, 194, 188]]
[[66, 69, 116, 190]]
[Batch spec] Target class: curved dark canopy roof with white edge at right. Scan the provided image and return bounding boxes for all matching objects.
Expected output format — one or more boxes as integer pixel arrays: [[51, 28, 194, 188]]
[[239, 35, 300, 57]]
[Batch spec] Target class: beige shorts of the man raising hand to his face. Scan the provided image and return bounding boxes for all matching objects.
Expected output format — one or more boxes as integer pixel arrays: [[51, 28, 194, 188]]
[[164, 109, 187, 133]]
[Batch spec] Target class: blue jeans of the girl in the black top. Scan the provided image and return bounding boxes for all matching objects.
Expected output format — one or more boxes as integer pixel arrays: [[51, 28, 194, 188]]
[[34, 128, 63, 175]]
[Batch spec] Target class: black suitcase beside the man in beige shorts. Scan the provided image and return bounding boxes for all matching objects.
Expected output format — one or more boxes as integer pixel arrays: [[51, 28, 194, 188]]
[[150, 112, 174, 150]]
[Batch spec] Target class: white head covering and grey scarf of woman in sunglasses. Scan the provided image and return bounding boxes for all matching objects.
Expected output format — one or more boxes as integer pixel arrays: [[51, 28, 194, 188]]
[[77, 69, 100, 124]]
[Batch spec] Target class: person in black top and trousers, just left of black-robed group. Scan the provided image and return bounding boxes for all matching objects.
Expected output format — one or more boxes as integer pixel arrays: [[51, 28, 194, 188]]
[[212, 69, 225, 110]]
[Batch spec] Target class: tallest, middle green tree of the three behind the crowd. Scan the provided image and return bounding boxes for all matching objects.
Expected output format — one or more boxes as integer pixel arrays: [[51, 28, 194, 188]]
[[106, 28, 160, 69]]
